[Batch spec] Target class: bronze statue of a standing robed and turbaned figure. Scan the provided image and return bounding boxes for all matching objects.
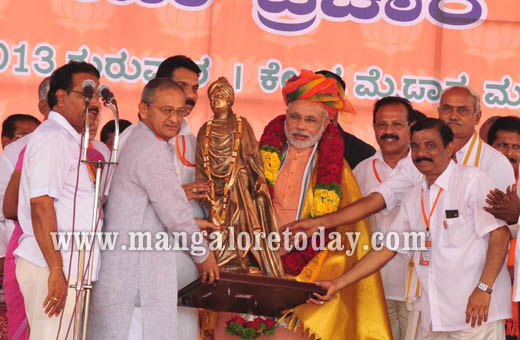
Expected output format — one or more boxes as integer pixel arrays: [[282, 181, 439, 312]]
[[195, 77, 285, 277]]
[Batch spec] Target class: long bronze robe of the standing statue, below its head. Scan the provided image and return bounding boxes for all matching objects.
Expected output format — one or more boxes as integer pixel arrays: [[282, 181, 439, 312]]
[[195, 113, 284, 277]]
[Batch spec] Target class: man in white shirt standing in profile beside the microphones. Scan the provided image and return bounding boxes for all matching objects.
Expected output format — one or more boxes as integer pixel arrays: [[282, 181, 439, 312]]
[[14, 62, 101, 340]]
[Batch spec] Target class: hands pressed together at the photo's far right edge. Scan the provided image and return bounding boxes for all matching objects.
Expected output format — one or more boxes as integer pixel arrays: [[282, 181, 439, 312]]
[[484, 184, 520, 224]]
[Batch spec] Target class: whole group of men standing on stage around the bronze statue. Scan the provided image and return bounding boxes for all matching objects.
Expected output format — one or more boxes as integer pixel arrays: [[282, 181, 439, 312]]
[[0, 56, 520, 340]]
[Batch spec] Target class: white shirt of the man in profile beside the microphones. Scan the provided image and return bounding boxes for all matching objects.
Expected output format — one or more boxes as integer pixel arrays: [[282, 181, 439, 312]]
[[14, 111, 102, 281]]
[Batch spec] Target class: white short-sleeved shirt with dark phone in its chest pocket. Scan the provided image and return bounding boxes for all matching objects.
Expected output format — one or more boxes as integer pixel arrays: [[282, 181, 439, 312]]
[[387, 161, 511, 331]]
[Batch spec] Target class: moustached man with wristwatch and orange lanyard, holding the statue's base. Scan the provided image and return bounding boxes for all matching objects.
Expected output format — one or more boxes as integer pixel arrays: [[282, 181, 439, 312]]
[[314, 118, 511, 340]]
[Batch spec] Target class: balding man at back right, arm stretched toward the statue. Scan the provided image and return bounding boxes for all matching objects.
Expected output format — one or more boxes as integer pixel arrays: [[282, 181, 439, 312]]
[[282, 86, 515, 244]]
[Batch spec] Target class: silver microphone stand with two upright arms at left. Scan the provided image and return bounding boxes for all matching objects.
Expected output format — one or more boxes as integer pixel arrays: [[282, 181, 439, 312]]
[[71, 93, 119, 340]]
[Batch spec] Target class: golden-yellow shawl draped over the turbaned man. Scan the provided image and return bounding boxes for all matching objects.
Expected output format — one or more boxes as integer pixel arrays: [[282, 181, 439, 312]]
[[285, 155, 392, 340]]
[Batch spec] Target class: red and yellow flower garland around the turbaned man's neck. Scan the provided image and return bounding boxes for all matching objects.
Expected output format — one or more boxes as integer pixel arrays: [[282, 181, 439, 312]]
[[260, 115, 343, 275]]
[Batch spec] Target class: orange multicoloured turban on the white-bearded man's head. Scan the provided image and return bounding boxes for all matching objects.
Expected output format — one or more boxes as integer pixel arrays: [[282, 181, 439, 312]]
[[282, 70, 355, 118]]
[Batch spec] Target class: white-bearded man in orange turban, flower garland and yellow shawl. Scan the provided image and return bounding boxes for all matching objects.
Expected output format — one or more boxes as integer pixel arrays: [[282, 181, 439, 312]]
[[260, 70, 391, 340]]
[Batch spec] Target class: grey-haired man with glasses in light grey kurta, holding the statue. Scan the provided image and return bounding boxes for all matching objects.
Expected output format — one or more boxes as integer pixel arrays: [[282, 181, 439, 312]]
[[88, 78, 219, 340]]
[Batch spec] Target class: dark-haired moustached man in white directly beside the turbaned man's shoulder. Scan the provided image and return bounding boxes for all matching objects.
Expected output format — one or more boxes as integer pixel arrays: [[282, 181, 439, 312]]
[[354, 97, 415, 340]]
